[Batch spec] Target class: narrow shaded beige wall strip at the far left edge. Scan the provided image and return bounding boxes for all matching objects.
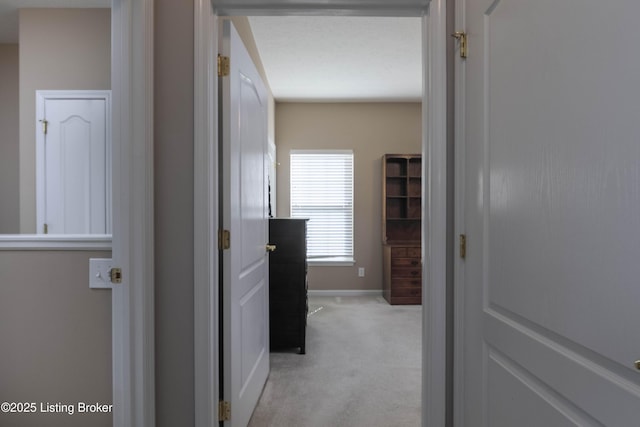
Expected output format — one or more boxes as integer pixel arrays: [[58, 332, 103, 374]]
[[0, 44, 20, 234]]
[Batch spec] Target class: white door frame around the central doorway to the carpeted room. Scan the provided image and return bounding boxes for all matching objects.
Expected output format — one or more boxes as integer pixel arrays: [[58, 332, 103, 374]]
[[194, 0, 448, 427]]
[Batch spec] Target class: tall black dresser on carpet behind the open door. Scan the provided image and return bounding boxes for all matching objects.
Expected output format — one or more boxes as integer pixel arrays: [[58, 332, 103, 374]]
[[269, 218, 308, 354]]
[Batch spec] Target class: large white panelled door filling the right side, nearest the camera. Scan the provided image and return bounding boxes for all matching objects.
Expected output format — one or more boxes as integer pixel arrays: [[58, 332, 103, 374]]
[[456, 0, 640, 427]]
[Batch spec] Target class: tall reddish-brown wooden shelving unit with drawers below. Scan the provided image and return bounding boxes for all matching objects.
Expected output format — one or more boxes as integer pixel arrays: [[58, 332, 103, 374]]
[[382, 154, 422, 304]]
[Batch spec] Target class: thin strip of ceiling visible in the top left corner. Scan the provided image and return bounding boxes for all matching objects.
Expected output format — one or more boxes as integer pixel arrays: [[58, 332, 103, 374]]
[[0, 0, 111, 43]]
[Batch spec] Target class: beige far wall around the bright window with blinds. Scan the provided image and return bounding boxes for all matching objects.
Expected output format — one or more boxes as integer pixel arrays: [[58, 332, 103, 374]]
[[275, 103, 422, 290]]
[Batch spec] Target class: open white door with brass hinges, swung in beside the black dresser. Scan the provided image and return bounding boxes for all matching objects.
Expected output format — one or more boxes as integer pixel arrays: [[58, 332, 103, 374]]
[[220, 21, 269, 427]]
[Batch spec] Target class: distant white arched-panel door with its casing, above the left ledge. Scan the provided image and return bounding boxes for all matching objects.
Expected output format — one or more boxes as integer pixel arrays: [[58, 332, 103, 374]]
[[36, 92, 111, 234]]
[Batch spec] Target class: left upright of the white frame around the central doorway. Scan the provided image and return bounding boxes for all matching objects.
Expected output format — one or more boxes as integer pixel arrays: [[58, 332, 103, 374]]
[[193, 0, 219, 427]]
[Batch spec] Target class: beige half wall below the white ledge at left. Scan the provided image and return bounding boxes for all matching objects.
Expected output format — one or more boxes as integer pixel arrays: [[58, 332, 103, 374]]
[[0, 251, 113, 427]]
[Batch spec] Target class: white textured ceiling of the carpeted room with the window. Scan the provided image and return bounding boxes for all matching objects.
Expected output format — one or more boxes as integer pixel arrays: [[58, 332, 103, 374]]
[[249, 16, 422, 101]]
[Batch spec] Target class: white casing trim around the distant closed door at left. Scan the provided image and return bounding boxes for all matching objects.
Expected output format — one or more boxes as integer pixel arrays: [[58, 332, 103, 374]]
[[35, 90, 113, 235]]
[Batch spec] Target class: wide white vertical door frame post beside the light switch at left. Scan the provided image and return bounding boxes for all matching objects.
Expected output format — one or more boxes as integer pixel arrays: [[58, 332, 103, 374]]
[[111, 0, 155, 427]]
